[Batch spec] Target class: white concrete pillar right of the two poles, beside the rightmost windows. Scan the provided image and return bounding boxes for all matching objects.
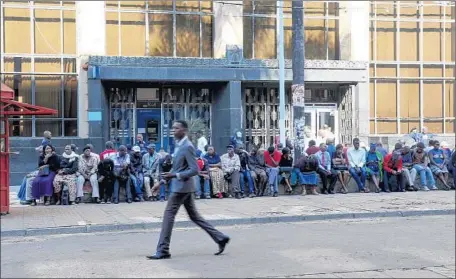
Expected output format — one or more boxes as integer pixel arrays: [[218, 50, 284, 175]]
[[339, 1, 370, 141]]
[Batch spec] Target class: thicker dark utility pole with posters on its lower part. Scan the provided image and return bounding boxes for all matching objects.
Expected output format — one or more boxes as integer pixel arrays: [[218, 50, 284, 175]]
[[291, 0, 306, 159]]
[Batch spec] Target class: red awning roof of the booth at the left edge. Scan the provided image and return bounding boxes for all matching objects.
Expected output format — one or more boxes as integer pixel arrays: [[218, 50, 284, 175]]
[[0, 83, 58, 116]]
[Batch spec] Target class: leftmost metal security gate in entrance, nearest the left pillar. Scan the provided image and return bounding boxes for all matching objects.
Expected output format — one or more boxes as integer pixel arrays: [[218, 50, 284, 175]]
[[108, 88, 136, 146]]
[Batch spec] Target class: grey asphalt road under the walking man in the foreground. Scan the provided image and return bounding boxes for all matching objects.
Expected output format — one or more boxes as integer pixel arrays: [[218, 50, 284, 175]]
[[1, 215, 455, 278]]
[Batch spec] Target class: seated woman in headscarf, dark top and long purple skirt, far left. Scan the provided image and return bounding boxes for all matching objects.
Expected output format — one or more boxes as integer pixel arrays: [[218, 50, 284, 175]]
[[32, 144, 60, 206]]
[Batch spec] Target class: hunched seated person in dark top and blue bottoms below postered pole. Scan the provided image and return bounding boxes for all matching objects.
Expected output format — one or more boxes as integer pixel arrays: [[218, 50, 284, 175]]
[[293, 155, 318, 196]]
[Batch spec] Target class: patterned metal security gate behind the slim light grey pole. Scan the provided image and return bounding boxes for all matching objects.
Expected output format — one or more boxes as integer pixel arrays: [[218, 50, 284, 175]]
[[243, 87, 292, 149]]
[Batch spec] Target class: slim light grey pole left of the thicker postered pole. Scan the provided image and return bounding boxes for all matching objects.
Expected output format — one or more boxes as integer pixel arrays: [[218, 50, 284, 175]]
[[277, 0, 286, 146]]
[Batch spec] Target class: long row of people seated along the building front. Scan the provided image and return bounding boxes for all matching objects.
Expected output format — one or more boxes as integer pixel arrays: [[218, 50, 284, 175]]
[[18, 132, 456, 205]]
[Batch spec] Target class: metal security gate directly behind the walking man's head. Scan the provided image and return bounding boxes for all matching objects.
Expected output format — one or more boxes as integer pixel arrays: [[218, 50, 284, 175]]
[[161, 87, 212, 152]]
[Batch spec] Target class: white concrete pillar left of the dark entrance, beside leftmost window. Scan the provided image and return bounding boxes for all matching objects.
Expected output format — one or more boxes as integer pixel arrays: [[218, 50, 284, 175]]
[[76, 1, 106, 138]]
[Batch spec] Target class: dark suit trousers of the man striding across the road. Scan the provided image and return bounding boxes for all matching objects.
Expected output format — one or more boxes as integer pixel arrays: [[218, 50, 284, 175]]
[[157, 193, 226, 254]]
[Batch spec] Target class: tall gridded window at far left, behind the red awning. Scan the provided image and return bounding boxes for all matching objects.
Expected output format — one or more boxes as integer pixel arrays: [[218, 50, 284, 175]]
[[0, 1, 78, 137]]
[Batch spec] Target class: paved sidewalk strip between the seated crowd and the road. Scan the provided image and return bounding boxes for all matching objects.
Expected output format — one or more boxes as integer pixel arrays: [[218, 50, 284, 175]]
[[1, 191, 455, 237]]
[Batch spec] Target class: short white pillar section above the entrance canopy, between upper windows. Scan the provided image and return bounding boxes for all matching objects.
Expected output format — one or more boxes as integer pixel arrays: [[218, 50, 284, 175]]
[[213, 1, 244, 58]]
